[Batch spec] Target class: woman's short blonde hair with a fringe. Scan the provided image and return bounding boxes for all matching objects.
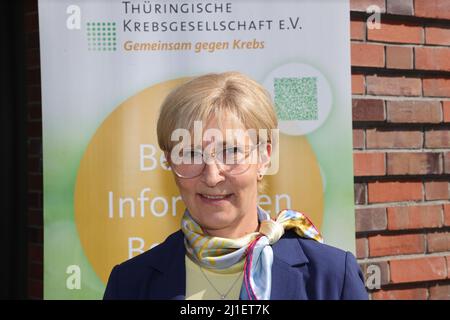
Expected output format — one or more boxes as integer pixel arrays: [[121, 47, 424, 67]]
[[156, 72, 278, 189]]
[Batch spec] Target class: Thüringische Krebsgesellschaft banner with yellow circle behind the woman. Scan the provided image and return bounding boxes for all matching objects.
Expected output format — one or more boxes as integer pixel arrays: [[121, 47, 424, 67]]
[[39, 0, 355, 299]]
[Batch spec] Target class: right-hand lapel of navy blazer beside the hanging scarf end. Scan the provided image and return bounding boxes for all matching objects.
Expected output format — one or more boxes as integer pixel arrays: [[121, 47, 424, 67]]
[[270, 234, 309, 300]]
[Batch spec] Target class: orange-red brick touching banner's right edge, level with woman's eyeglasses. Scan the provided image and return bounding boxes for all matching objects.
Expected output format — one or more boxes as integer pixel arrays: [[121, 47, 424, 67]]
[[353, 152, 386, 176]]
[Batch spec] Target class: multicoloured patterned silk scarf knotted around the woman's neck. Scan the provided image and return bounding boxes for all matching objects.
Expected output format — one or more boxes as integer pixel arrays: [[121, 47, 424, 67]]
[[181, 207, 323, 300]]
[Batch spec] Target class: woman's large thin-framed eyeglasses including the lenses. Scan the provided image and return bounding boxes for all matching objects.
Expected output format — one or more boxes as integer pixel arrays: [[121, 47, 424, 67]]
[[170, 142, 262, 179]]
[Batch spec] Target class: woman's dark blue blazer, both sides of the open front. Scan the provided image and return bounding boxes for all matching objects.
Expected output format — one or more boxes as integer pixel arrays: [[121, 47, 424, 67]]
[[103, 230, 368, 300]]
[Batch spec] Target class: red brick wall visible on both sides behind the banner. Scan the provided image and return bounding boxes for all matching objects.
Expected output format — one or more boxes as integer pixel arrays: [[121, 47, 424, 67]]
[[24, 0, 450, 299]]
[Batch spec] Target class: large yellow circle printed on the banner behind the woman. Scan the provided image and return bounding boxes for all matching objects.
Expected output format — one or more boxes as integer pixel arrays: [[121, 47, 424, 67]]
[[74, 78, 324, 283]]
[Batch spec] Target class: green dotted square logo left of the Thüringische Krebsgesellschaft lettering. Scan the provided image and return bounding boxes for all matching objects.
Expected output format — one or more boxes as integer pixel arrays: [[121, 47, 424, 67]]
[[86, 21, 117, 51]]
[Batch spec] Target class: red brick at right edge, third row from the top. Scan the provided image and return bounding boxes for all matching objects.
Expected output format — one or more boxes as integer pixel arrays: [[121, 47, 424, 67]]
[[415, 47, 450, 71]]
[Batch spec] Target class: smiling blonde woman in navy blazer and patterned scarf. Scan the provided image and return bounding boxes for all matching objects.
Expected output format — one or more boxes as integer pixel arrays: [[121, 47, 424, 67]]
[[104, 72, 367, 300]]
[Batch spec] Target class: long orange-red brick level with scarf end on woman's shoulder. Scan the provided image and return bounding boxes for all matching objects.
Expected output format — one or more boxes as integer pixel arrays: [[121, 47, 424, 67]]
[[387, 205, 442, 230]]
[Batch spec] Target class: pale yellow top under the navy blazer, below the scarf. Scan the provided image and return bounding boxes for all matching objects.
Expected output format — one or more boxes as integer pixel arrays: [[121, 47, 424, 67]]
[[184, 256, 244, 300]]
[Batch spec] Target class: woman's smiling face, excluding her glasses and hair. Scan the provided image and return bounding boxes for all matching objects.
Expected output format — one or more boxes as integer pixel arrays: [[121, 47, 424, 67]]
[[168, 116, 270, 238]]
